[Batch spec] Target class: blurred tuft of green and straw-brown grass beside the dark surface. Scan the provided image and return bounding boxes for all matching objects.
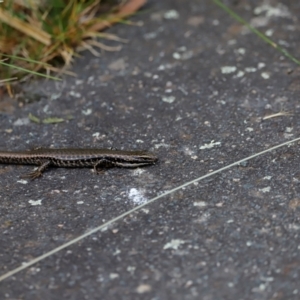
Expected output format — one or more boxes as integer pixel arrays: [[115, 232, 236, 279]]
[[0, 0, 146, 85]]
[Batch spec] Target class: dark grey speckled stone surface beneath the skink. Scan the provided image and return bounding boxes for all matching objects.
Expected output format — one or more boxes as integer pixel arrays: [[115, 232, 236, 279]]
[[0, 0, 300, 300]]
